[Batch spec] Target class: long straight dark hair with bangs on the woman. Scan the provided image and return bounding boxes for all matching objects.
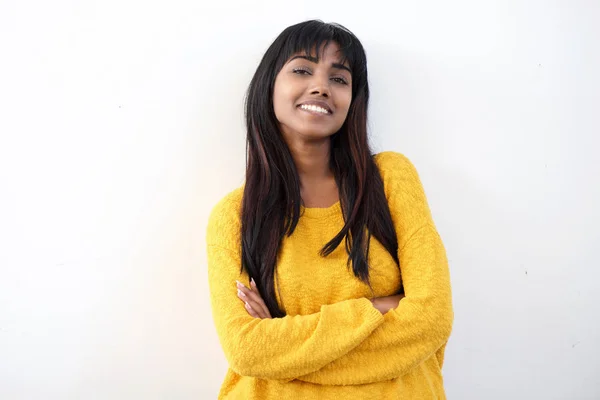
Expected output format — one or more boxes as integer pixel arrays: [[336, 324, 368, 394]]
[[241, 20, 399, 318]]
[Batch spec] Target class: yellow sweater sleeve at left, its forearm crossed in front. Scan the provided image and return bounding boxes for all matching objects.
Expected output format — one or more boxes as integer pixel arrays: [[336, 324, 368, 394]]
[[207, 189, 383, 381]]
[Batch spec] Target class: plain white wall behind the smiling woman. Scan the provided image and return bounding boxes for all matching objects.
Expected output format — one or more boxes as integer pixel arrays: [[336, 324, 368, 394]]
[[0, 0, 600, 400]]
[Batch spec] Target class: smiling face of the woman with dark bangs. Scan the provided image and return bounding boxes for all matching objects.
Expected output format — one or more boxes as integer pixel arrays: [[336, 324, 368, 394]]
[[273, 42, 352, 140]]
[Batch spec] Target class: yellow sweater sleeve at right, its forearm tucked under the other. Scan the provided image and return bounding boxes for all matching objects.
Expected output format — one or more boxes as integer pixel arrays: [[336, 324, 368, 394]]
[[298, 155, 454, 385]]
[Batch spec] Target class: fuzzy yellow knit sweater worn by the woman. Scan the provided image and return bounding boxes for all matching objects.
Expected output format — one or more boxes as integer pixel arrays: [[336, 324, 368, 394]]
[[207, 151, 454, 400]]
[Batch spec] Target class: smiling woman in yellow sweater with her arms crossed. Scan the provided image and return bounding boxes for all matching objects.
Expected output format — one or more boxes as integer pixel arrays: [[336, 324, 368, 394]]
[[207, 21, 453, 400]]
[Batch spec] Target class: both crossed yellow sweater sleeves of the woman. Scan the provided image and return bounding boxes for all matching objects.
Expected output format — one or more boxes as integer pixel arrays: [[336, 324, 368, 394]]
[[207, 152, 454, 385]]
